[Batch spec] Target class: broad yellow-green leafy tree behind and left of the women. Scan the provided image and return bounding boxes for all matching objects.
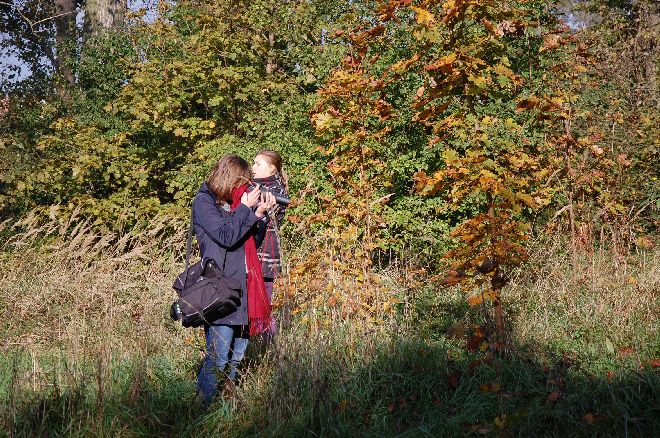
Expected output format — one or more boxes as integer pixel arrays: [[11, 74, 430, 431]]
[[0, 1, 350, 229]]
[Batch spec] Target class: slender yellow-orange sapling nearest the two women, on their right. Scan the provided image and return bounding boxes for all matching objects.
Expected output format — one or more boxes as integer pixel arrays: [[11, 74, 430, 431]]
[[294, 21, 392, 316]]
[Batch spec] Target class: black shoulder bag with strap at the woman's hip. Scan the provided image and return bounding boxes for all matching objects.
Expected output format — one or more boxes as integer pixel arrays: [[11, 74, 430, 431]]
[[170, 210, 242, 327]]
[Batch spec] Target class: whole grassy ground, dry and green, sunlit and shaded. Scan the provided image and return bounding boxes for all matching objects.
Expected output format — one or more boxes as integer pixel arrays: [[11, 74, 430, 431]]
[[0, 221, 660, 437]]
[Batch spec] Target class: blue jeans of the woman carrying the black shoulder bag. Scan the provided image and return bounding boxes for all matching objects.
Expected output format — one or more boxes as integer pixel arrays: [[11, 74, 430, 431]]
[[197, 325, 249, 406]]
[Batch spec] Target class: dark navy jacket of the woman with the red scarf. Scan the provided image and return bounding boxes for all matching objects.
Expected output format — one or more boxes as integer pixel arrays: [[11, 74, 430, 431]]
[[192, 183, 266, 325]]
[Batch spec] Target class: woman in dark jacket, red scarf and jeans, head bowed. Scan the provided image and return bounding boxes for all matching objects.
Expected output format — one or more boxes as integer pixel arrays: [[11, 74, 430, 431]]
[[192, 155, 275, 406]]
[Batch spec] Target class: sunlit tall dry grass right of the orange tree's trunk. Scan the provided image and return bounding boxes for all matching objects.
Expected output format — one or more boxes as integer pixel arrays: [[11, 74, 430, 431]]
[[504, 239, 660, 364]]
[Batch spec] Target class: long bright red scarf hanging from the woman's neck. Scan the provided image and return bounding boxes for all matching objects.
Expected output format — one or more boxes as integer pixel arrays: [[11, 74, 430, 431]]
[[231, 184, 272, 336]]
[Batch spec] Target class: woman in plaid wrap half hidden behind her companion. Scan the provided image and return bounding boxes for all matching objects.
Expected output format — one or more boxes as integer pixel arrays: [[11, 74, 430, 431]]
[[252, 149, 288, 335]]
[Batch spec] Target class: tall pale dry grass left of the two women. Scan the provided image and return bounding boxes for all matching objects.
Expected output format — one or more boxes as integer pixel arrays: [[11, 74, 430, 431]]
[[0, 212, 191, 355]]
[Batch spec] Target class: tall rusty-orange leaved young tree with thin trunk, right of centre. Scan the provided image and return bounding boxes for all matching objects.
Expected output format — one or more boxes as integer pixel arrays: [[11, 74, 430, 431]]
[[350, 0, 549, 341]]
